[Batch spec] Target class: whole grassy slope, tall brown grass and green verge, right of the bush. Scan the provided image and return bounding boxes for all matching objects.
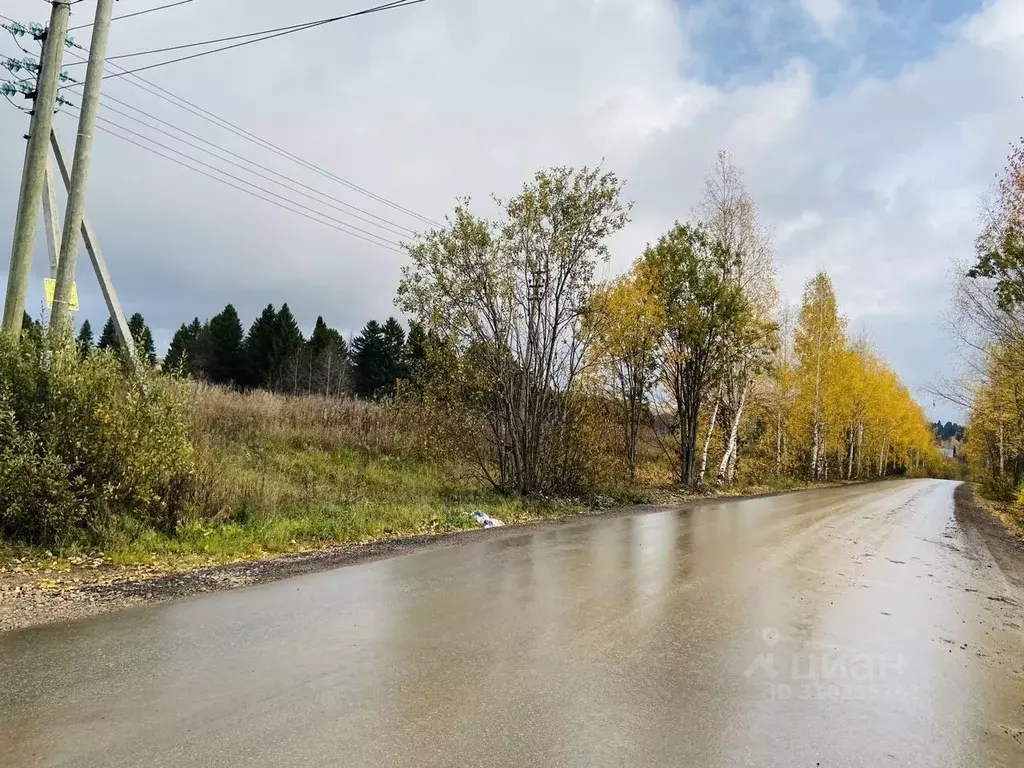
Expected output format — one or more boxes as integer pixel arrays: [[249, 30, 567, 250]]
[[0, 387, 588, 570]]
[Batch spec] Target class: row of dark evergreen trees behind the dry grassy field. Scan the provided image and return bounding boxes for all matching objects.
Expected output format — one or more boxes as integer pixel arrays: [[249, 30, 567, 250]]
[[68, 303, 427, 398]]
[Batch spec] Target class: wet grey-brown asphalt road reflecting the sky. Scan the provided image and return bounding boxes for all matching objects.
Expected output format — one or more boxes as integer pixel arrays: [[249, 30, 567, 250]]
[[0, 480, 1024, 768]]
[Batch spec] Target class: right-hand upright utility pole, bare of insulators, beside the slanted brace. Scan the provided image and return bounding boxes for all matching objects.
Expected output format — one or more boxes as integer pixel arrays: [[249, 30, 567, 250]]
[[50, 0, 114, 334]]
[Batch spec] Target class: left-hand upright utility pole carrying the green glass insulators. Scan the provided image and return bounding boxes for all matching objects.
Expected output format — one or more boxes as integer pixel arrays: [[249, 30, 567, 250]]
[[3, 0, 71, 338]]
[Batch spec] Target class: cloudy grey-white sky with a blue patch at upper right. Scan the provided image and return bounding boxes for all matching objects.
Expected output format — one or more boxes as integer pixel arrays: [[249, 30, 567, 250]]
[[0, 0, 1024, 419]]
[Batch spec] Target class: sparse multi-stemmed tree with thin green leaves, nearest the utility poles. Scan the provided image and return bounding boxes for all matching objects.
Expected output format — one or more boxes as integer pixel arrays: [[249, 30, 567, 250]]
[[397, 168, 629, 494]]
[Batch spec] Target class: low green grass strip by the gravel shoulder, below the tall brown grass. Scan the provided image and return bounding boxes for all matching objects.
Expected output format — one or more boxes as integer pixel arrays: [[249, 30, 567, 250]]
[[0, 444, 589, 570]]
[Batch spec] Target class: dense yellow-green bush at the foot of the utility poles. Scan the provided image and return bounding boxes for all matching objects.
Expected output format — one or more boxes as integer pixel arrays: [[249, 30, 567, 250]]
[[0, 335, 195, 546]]
